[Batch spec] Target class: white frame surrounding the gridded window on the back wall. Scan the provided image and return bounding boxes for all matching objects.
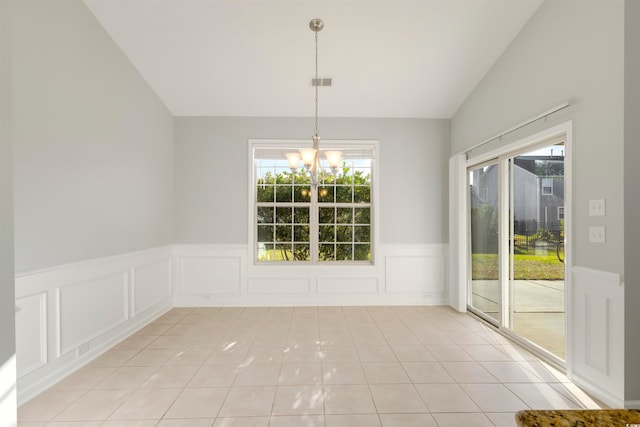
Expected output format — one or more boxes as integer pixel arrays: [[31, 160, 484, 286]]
[[247, 138, 380, 268]]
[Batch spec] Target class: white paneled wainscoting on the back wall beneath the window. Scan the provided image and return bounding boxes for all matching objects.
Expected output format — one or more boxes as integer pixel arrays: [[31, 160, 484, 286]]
[[174, 244, 448, 307]]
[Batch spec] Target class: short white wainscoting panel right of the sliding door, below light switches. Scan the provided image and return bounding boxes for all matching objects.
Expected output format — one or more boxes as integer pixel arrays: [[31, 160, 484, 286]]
[[569, 267, 625, 407]]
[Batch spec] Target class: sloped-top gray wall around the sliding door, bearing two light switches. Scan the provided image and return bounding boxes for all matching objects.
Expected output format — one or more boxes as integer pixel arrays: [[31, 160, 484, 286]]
[[451, 0, 624, 274]]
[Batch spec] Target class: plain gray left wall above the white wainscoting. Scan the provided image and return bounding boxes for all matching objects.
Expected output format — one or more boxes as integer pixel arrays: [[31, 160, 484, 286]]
[[12, 0, 173, 272]]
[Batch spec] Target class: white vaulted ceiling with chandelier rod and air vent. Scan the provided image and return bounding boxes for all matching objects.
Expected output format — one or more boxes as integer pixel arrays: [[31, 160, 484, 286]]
[[84, 0, 542, 118]]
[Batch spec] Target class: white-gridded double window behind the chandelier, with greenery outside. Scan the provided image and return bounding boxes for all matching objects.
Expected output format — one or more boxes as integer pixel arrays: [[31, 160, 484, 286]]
[[251, 141, 375, 263]]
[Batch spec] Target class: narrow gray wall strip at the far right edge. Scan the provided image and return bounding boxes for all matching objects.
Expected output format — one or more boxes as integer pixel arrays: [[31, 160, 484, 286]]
[[624, 0, 640, 400]]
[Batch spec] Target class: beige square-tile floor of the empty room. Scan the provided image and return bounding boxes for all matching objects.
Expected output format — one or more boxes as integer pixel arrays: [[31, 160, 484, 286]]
[[18, 306, 598, 427]]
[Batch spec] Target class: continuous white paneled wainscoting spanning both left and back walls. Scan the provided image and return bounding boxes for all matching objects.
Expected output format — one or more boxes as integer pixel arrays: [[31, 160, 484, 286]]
[[16, 244, 448, 404]]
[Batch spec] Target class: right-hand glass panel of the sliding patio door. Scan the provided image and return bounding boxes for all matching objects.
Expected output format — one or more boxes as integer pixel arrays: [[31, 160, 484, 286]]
[[508, 143, 566, 359]]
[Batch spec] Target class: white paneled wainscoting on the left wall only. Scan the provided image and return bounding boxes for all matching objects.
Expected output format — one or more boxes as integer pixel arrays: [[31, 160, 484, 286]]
[[16, 246, 173, 404]]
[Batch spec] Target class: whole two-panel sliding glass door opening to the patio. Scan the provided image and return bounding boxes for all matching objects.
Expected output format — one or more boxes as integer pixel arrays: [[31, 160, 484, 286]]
[[467, 137, 566, 361]]
